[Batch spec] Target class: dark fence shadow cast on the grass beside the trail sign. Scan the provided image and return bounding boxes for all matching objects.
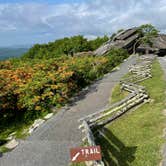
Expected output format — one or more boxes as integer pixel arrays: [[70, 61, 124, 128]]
[[97, 128, 137, 166]]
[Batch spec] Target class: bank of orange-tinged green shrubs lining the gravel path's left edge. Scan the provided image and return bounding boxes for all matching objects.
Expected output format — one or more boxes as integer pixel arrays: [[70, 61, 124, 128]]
[[0, 49, 128, 139]]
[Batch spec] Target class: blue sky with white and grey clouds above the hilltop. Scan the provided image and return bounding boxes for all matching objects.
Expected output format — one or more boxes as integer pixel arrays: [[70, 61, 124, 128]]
[[0, 0, 166, 46]]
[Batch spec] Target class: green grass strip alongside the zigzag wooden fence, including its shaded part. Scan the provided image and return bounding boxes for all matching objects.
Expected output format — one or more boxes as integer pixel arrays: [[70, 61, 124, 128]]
[[97, 61, 166, 166]]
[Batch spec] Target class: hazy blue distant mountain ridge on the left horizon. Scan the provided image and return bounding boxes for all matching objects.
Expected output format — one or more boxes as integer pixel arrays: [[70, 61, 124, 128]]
[[0, 47, 29, 60]]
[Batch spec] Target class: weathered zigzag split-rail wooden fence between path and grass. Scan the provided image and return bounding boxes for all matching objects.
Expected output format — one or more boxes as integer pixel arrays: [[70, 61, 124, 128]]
[[79, 54, 156, 166]]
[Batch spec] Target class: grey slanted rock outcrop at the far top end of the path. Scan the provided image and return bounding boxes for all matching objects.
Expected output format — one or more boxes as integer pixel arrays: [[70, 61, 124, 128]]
[[93, 28, 166, 56]]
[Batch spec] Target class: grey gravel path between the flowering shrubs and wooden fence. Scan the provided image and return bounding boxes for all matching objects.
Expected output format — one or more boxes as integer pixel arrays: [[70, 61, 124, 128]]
[[0, 56, 137, 166]]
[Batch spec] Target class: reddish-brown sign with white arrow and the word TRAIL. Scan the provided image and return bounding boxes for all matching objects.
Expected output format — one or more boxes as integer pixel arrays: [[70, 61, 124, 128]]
[[70, 146, 101, 163]]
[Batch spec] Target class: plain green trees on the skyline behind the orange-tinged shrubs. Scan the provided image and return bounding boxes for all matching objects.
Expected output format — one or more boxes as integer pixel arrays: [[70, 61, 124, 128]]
[[22, 35, 109, 59]]
